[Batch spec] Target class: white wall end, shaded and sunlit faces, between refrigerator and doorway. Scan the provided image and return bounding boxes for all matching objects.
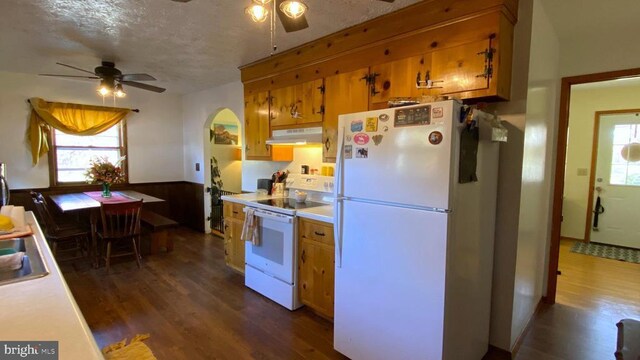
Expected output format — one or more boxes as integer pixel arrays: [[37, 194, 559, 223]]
[[490, 0, 560, 351]]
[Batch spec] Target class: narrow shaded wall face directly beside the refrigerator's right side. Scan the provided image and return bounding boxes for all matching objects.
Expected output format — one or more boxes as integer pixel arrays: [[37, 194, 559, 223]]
[[489, 0, 533, 350]]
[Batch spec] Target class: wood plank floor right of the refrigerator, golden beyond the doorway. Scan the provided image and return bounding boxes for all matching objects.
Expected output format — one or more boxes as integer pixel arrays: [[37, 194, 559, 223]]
[[516, 240, 640, 360]]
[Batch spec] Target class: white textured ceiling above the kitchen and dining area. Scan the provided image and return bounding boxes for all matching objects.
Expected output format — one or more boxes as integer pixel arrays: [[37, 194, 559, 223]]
[[0, 0, 419, 93]]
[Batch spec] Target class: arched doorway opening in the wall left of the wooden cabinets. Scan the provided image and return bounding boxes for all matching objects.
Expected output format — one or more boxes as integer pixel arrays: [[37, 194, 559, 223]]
[[203, 108, 243, 235]]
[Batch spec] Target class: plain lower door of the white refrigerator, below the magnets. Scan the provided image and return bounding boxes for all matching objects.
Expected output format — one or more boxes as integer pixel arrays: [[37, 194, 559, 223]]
[[334, 200, 449, 360]]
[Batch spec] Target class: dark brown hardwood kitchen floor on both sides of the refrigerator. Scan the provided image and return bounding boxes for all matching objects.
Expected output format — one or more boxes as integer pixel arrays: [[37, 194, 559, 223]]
[[61, 227, 640, 360]]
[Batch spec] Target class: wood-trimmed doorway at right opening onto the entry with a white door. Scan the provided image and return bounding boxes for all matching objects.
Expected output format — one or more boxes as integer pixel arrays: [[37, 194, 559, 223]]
[[546, 69, 640, 321]]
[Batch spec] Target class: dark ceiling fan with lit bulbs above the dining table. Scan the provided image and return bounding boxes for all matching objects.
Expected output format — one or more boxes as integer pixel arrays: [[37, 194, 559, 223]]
[[39, 61, 166, 97]]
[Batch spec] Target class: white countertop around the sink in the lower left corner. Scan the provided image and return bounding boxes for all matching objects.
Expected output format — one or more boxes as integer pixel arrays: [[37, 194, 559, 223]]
[[0, 212, 103, 360]]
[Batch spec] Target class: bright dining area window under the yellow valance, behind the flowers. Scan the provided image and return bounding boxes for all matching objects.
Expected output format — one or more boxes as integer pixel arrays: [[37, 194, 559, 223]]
[[49, 122, 127, 186]]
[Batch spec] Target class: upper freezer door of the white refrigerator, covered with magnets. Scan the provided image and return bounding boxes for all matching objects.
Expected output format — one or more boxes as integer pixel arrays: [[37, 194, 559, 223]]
[[338, 101, 460, 209]]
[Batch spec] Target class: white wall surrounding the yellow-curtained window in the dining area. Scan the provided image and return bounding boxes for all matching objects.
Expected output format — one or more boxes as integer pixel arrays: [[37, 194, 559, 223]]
[[0, 72, 183, 189]]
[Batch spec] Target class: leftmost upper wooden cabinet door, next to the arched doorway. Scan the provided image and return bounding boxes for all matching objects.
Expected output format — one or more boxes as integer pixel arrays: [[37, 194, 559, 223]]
[[244, 91, 271, 160]]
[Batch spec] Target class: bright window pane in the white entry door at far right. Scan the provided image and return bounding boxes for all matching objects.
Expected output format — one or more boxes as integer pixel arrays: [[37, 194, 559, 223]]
[[609, 124, 640, 186]]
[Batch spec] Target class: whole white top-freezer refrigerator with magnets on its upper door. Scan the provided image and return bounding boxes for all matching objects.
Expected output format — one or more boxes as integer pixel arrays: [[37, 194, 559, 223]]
[[334, 100, 498, 360]]
